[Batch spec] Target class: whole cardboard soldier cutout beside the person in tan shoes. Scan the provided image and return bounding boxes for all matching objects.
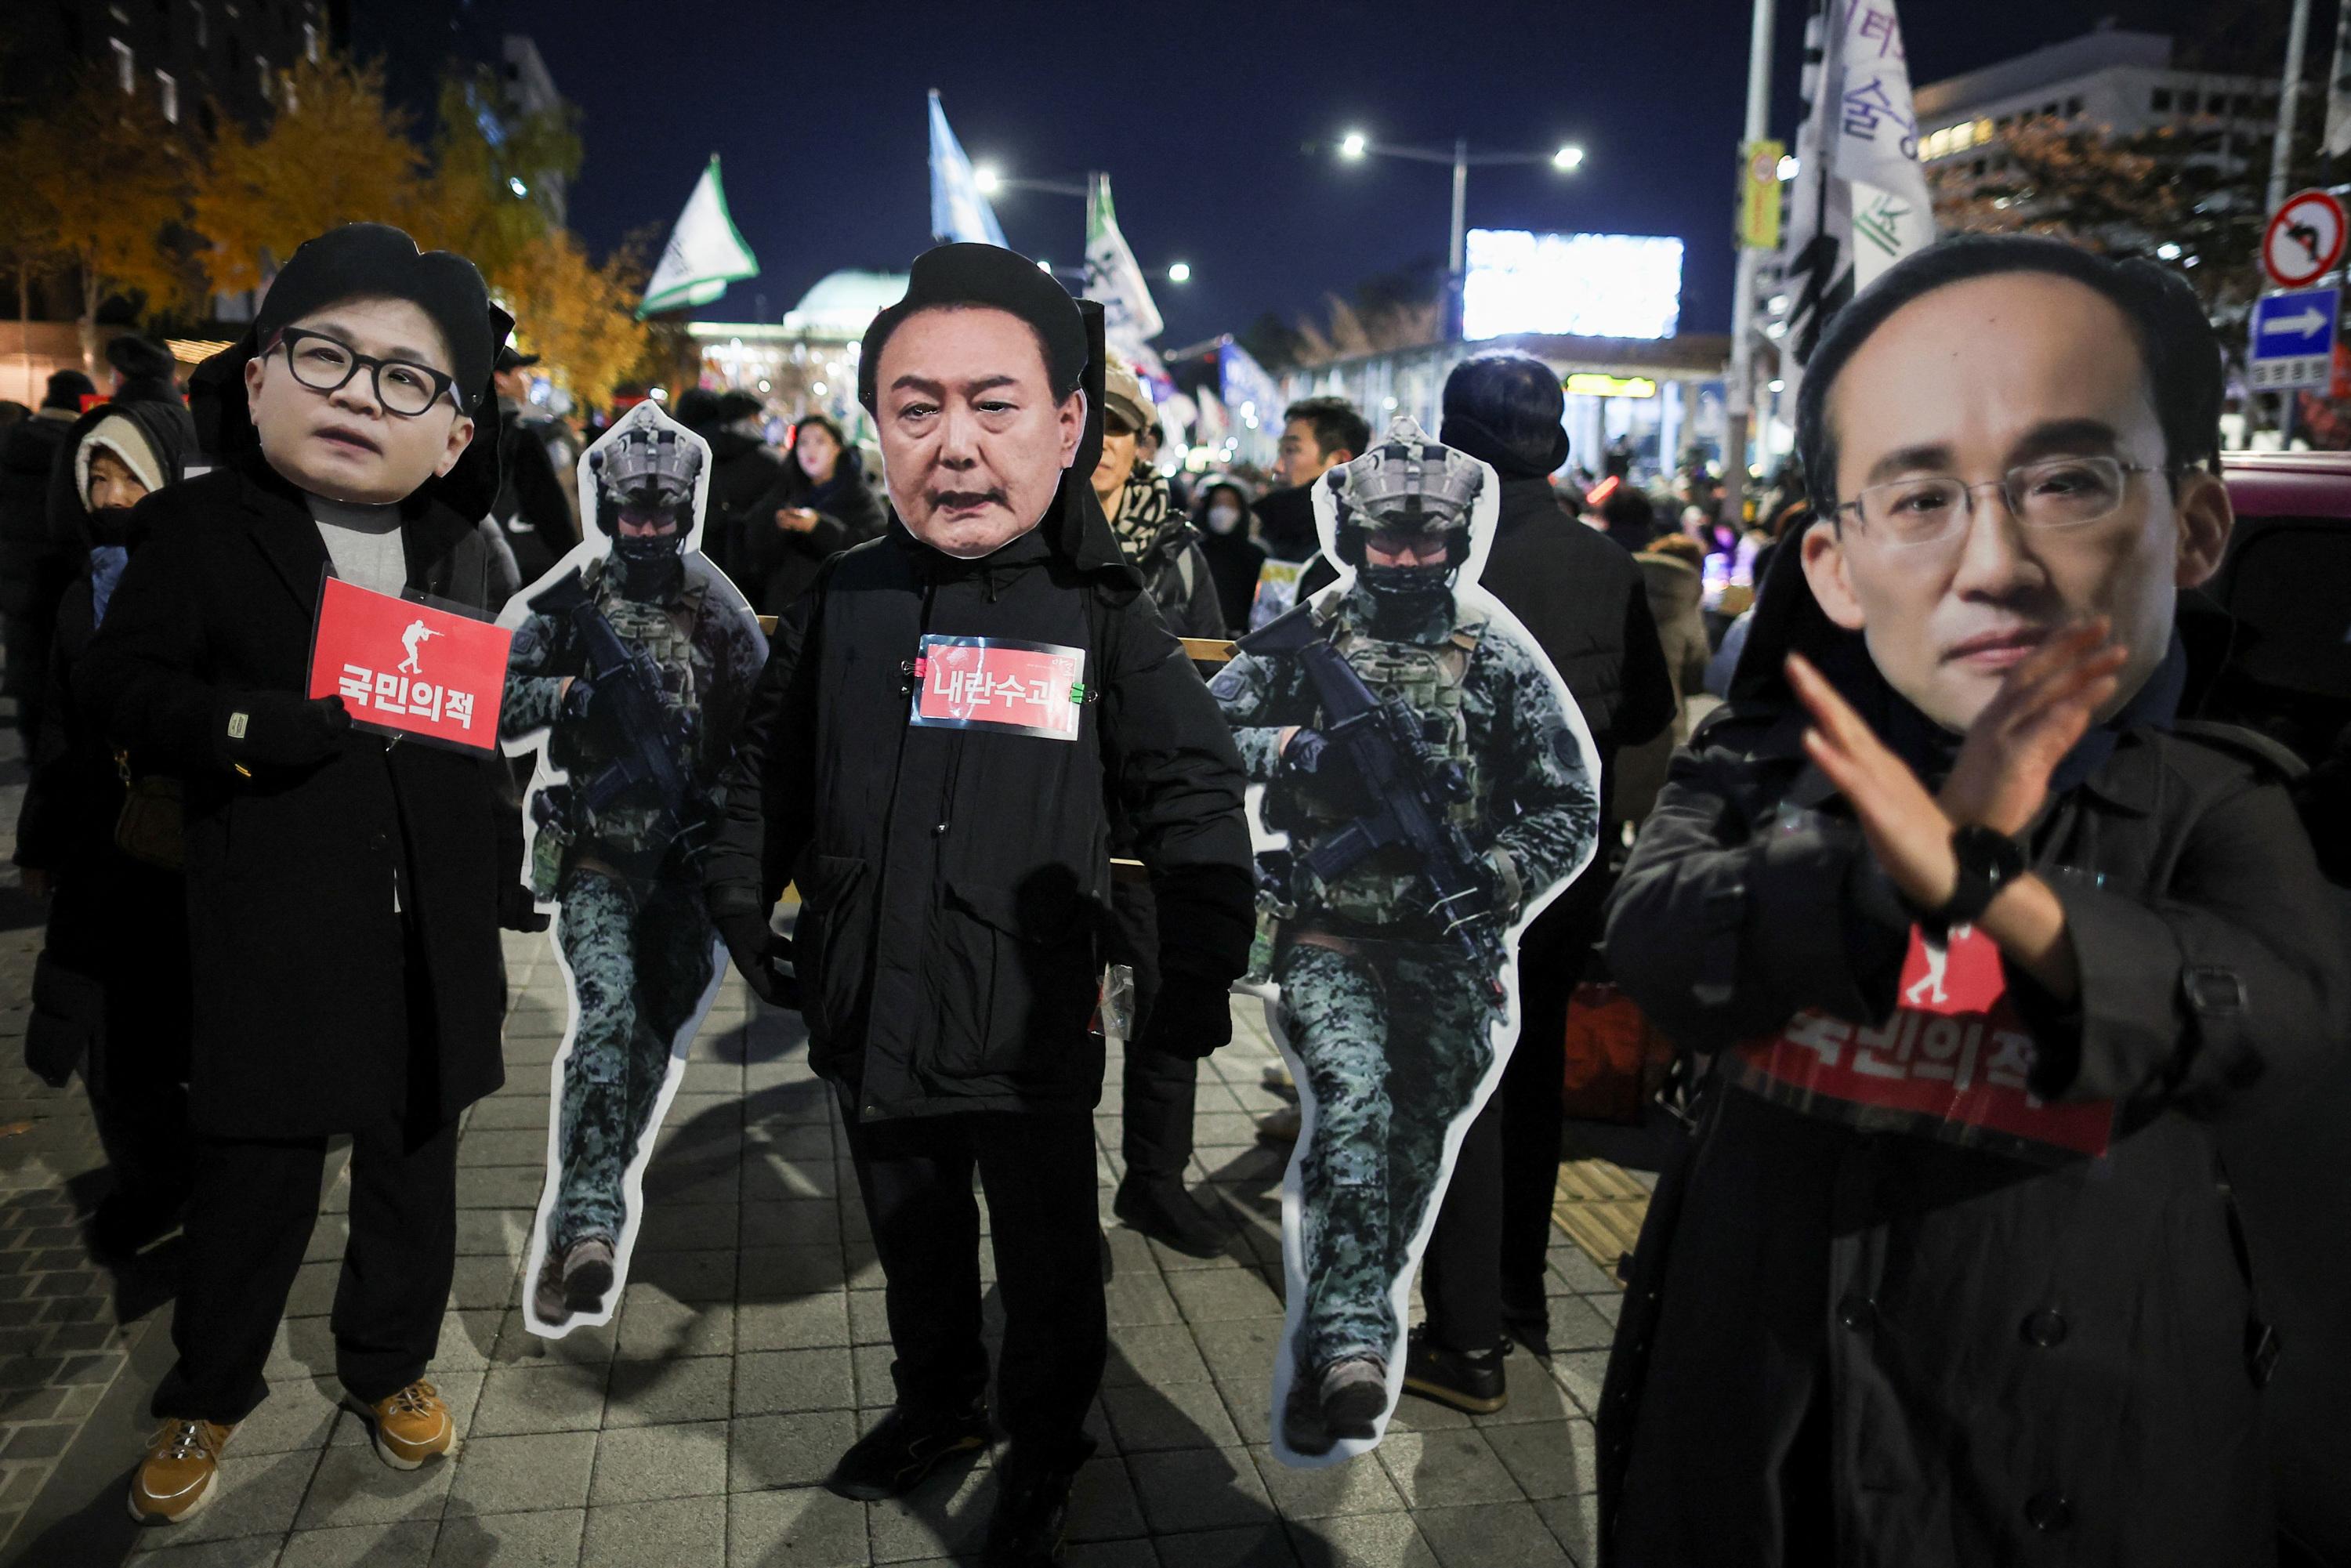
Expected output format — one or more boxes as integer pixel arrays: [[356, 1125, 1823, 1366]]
[[501, 402, 766, 1338]]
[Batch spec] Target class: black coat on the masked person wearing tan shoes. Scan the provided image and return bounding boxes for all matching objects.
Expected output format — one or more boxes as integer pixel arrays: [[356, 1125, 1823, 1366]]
[[75, 456, 522, 1138]]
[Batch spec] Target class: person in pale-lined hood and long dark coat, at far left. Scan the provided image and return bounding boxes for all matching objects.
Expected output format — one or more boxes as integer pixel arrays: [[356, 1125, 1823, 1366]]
[[16, 402, 195, 1258]]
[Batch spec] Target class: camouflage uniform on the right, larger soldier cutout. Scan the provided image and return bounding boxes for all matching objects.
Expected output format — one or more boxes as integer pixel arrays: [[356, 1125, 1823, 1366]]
[[1211, 585, 1599, 1375]]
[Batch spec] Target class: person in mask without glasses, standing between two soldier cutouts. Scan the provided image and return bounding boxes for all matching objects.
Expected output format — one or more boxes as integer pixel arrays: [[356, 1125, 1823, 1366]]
[[705, 244, 1253, 1568]]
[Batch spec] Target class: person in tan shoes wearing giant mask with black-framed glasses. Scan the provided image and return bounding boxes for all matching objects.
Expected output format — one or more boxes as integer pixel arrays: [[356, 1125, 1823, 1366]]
[[75, 223, 538, 1521]]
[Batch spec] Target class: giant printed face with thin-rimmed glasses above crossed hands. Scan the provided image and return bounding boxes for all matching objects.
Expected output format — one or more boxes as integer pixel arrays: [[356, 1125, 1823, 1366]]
[[1803, 273, 2231, 731]]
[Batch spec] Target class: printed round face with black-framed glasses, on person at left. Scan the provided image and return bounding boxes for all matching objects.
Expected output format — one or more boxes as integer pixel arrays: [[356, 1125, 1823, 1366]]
[[245, 299, 473, 505]]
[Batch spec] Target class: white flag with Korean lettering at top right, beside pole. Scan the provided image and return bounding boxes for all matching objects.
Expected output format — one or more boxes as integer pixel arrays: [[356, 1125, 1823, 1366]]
[[1782, 0, 1935, 364]]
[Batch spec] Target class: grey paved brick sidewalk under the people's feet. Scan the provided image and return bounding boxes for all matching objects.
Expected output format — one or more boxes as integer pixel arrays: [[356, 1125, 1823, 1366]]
[[0, 933, 1615, 1568]]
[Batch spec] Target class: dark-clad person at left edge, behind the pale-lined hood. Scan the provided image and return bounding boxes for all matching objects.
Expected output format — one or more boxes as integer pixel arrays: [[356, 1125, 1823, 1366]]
[[0, 369, 99, 757]]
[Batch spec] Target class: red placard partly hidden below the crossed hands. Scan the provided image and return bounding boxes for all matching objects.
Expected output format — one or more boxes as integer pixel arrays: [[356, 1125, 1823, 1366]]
[[1733, 926, 2114, 1161]]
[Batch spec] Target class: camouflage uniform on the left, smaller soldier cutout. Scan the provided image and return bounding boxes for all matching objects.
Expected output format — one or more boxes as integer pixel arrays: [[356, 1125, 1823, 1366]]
[[501, 555, 764, 1253]]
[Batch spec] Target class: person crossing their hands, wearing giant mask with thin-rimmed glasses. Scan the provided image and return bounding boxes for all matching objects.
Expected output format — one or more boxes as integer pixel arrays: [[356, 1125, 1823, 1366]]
[[1599, 235, 2351, 1568]]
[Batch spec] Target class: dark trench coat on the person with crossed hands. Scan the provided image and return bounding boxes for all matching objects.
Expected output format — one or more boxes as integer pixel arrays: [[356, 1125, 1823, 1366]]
[[1601, 672, 2351, 1568]]
